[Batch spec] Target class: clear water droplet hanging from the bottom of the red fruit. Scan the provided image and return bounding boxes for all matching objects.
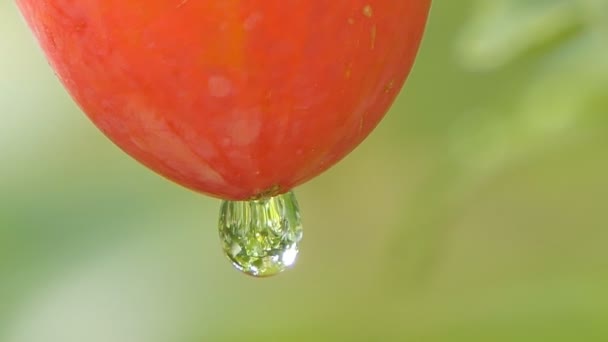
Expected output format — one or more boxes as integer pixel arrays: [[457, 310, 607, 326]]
[[219, 192, 302, 277]]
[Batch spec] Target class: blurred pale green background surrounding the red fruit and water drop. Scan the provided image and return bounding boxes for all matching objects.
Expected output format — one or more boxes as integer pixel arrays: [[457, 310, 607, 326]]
[[0, 0, 608, 342]]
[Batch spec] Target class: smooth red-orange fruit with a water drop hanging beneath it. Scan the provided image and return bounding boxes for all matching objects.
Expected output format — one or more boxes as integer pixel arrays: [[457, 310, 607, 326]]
[[16, 0, 431, 200]]
